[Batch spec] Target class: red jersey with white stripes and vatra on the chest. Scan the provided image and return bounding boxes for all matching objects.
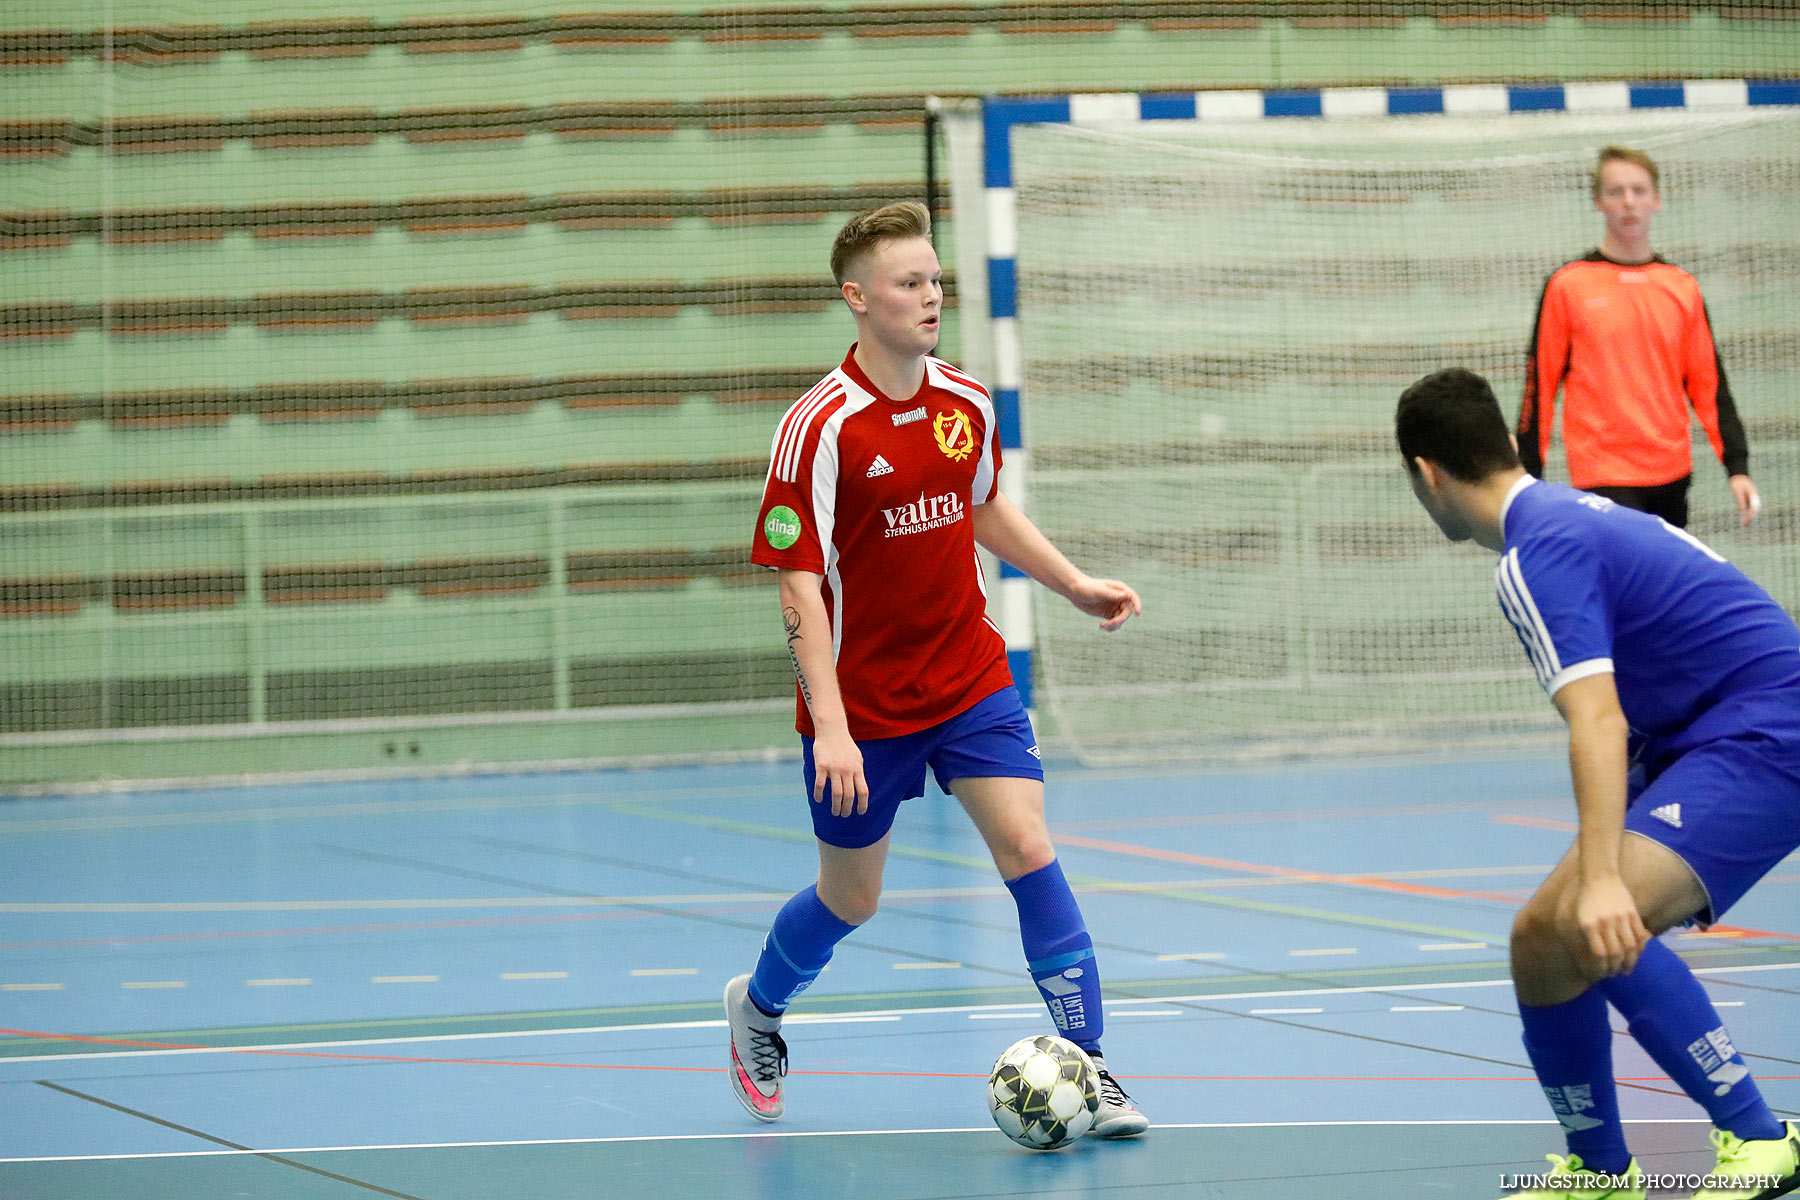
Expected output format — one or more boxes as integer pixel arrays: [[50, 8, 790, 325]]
[[751, 345, 1012, 739]]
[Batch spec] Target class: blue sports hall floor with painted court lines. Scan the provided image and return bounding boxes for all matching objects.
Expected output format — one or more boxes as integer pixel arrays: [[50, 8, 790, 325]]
[[0, 756, 1800, 1200]]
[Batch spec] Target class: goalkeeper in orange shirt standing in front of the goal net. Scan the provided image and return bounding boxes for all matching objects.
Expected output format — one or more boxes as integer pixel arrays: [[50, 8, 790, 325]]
[[1517, 146, 1762, 527]]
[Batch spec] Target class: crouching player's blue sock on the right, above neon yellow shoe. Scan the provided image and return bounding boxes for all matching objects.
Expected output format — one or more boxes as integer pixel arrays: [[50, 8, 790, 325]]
[[1598, 937, 1784, 1141]]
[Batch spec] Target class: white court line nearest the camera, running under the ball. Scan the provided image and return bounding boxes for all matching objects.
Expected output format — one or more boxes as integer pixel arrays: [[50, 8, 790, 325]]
[[0, 1117, 1712, 1162]]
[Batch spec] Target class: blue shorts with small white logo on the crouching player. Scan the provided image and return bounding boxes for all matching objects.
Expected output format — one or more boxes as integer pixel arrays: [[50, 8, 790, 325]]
[[1625, 689, 1800, 925]]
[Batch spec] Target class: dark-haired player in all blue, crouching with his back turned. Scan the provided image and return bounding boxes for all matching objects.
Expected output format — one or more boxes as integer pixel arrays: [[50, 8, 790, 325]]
[[1395, 369, 1800, 1200]]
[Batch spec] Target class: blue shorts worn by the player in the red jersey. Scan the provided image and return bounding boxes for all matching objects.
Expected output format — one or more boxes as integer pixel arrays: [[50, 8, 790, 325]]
[[799, 687, 1044, 849]]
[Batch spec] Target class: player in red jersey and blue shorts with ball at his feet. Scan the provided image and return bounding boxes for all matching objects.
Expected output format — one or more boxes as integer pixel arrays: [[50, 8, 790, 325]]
[[725, 203, 1150, 1137]]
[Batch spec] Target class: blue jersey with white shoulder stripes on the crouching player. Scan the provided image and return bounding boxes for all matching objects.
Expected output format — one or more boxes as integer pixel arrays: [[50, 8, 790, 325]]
[[1494, 477, 1800, 738]]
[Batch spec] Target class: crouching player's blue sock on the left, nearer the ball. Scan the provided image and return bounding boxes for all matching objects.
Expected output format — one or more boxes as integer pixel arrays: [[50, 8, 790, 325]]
[[1519, 988, 1631, 1173]]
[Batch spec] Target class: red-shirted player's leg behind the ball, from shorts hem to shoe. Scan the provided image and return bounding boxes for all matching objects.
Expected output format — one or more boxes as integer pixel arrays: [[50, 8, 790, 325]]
[[950, 777, 1150, 1137]]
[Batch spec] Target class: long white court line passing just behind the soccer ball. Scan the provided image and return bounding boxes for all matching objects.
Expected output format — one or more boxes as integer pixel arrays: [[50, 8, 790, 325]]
[[0, 963, 1800, 1072]]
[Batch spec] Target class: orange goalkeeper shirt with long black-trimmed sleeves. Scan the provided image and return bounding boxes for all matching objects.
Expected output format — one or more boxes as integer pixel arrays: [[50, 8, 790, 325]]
[[1519, 250, 1750, 488]]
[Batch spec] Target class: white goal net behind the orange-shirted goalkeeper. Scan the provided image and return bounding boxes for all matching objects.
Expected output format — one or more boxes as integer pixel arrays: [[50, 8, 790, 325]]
[[1012, 110, 1800, 761]]
